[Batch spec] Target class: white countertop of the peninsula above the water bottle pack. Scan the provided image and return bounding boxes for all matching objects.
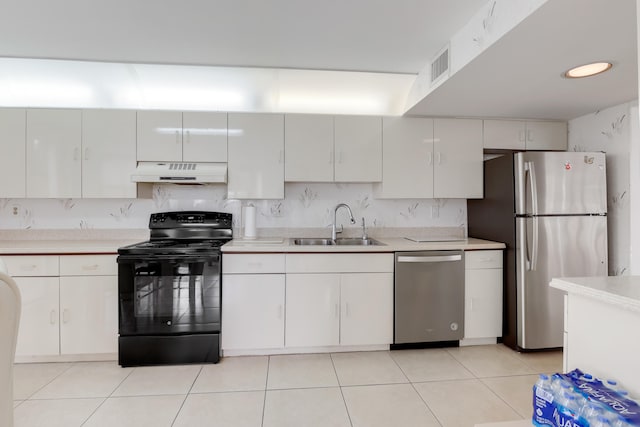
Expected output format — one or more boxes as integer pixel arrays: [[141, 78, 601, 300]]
[[549, 276, 640, 312]]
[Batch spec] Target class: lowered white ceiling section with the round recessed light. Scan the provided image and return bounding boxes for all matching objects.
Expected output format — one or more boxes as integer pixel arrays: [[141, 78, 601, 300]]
[[409, 0, 638, 120]]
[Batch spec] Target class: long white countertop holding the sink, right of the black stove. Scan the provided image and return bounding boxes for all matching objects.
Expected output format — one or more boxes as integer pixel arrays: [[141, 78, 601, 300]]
[[222, 237, 505, 253]]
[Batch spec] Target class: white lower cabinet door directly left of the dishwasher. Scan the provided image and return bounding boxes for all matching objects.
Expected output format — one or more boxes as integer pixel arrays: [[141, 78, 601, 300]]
[[340, 273, 393, 345]]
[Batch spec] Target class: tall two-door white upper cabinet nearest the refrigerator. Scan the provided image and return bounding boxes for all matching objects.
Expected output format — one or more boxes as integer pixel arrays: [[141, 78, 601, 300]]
[[374, 117, 483, 199]]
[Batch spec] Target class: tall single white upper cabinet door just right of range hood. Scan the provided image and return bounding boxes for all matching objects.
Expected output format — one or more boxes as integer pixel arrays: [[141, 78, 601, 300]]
[[227, 113, 284, 199]]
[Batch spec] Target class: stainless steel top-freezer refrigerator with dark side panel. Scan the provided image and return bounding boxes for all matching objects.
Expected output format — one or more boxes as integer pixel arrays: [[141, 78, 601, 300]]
[[467, 151, 608, 351]]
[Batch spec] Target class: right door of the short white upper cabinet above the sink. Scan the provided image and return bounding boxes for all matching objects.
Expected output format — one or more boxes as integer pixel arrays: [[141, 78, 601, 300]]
[[334, 116, 382, 182]]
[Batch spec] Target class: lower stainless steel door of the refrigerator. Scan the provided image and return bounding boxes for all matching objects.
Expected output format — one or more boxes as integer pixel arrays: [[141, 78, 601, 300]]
[[516, 216, 607, 349]]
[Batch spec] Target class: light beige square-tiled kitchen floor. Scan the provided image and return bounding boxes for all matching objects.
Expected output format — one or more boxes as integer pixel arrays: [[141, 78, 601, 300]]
[[14, 345, 562, 427]]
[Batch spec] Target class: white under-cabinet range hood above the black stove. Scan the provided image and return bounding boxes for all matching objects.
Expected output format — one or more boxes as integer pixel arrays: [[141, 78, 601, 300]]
[[131, 162, 227, 184]]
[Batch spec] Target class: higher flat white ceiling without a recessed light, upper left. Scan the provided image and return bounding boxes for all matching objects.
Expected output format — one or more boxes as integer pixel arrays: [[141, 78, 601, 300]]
[[0, 0, 487, 74]]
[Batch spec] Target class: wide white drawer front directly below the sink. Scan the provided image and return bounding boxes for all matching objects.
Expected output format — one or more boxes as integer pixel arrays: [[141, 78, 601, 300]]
[[287, 253, 394, 273]]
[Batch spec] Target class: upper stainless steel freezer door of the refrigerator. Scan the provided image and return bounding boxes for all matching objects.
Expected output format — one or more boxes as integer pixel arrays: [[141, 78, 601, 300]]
[[514, 152, 607, 215]]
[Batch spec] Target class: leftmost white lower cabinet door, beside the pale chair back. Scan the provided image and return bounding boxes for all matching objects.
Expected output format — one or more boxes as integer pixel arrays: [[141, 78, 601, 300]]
[[15, 277, 60, 356]]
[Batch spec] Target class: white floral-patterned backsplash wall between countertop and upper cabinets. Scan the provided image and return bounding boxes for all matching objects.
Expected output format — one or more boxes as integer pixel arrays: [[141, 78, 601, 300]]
[[0, 183, 467, 234]]
